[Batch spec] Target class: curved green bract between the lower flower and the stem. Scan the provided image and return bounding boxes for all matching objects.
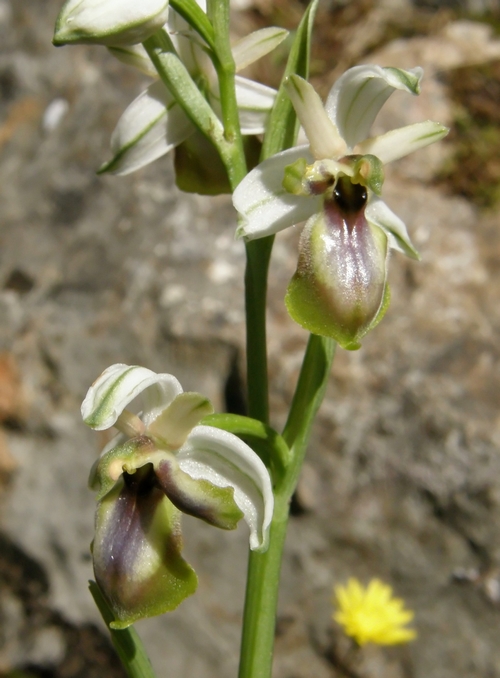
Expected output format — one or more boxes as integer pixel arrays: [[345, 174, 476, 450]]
[[201, 414, 290, 485]]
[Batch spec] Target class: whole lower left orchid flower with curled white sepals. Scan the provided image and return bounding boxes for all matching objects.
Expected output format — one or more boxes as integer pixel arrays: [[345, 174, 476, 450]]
[[82, 364, 274, 628]]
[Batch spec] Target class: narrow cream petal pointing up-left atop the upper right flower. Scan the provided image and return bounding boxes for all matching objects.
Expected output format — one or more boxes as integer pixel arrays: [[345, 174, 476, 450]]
[[285, 75, 347, 160]]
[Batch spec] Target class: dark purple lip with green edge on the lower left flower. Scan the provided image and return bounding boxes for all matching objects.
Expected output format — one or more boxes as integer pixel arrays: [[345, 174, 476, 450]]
[[93, 464, 196, 626]]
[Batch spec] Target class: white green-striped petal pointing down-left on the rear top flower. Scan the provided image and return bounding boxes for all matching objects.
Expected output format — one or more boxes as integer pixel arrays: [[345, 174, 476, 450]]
[[99, 81, 194, 175]]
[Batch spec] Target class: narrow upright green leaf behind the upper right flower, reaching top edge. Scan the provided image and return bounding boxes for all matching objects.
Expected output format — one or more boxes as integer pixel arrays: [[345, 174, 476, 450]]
[[261, 0, 318, 160]]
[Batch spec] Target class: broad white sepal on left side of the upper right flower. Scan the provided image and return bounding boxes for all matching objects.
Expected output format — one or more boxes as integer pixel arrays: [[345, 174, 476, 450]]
[[233, 146, 321, 240]]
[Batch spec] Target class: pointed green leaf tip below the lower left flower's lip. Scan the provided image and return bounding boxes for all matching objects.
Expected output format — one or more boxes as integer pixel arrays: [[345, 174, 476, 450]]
[[89, 581, 156, 678]]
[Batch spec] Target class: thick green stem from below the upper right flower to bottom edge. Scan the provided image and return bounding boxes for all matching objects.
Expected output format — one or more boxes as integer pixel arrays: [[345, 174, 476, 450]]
[[239, 334, 336, 678]]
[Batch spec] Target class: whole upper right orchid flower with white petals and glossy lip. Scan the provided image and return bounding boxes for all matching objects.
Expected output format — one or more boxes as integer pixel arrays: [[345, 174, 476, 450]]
[[233, 66, 448, 349]]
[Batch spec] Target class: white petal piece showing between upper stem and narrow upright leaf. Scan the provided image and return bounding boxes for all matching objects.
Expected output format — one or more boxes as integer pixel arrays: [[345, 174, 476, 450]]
[[235, 76, 276, 134]]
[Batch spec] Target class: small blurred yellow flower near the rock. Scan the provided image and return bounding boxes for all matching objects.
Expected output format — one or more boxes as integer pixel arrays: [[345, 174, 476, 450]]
[[333, 577, 417, 645]]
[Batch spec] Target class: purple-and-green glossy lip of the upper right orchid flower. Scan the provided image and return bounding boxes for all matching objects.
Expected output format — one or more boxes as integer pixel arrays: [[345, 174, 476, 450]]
[[286, 177, 388, 348]]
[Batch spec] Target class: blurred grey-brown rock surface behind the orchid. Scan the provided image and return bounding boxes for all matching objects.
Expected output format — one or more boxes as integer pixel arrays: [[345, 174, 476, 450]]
[[0, 0, 500, 678]]
